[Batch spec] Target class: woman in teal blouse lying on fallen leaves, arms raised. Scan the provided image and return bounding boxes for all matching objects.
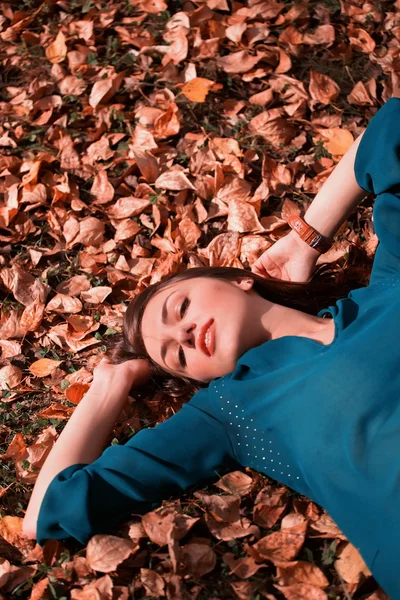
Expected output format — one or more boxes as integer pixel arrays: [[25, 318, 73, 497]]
[[24, 98, 400, 598]]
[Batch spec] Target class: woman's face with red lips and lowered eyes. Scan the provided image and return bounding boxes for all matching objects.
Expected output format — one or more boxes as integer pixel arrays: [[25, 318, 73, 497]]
[[142, 277, 261, 382]]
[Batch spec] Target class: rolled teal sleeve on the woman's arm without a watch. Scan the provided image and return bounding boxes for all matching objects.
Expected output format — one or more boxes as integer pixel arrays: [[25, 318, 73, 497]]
[[36, 388, 240, 546]]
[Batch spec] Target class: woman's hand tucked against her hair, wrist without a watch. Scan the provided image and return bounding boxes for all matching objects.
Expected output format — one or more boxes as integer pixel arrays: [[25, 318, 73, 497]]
[[93, 356, 151, 389]]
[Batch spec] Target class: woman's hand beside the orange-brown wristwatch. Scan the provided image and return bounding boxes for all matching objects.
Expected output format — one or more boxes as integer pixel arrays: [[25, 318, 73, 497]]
[[251, 231, 320, 283]]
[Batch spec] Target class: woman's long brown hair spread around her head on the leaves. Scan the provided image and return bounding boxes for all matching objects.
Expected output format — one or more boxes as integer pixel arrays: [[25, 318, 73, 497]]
[[107, 265, 369, 396]]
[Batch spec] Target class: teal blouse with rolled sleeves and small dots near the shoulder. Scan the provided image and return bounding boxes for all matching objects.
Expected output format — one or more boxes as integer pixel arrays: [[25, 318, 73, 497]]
[[37, 98, 400, 600]]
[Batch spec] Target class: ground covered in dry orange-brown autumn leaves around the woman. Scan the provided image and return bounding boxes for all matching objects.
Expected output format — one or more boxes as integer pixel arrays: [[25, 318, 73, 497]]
[[0, 0, 400, 600]]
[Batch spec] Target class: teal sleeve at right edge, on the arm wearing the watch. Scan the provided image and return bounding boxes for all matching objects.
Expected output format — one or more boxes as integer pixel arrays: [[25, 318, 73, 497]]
[[354, 98, 400, 283]]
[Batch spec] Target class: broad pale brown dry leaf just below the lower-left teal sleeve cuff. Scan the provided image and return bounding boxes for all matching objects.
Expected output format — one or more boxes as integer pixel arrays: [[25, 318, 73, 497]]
[[86, 534, 139, 573]]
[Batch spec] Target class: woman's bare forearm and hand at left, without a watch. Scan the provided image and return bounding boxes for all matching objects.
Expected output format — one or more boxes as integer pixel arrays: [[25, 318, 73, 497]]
[[22, 359, 147, 539]]
